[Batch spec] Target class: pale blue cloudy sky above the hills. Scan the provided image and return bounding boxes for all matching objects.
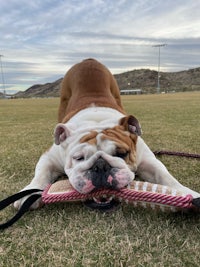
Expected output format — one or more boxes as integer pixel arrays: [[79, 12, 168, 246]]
[[0, 0, 200, 93]]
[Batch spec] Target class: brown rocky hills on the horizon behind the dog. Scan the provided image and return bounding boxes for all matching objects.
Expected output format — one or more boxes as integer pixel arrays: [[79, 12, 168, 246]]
[[14, 67, 200, 98]]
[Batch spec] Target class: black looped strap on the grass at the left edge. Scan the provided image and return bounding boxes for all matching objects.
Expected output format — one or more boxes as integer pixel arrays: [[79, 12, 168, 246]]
[[0, 189, 42, 230]]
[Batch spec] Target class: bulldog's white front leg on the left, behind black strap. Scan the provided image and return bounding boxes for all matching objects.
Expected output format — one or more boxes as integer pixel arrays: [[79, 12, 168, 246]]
[[14, 148, 64, 209]]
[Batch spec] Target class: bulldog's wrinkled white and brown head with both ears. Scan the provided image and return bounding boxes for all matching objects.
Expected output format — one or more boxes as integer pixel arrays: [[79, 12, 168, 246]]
[[55, 116, 141, 194]]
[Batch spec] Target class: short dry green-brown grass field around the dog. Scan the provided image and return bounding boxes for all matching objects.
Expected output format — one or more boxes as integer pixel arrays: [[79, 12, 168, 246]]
[[0, 93, 200, 267]]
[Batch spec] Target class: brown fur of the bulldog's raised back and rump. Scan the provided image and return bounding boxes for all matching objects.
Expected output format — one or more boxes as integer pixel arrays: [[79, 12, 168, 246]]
[[58, 59, 125, 123]]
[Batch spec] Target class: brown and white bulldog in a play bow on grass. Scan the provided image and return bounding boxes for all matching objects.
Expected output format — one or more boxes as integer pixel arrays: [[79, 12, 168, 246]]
[[14, 59, 200, 209]]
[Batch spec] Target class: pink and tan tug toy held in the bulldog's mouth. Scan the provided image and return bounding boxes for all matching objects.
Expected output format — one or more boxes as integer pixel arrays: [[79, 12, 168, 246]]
[[42, 180, 196, 212]]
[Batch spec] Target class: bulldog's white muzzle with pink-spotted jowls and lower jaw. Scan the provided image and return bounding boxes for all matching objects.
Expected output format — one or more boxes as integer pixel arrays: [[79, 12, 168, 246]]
[[66, 151, 135, 209]]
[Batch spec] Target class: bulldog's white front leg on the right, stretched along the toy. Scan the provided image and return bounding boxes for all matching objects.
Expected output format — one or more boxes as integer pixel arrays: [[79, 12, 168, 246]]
[[137, 138, 200, 198]]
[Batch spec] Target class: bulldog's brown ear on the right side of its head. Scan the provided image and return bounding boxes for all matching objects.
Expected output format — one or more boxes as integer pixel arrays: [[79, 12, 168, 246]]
[[119, 115, 142, 136]]
